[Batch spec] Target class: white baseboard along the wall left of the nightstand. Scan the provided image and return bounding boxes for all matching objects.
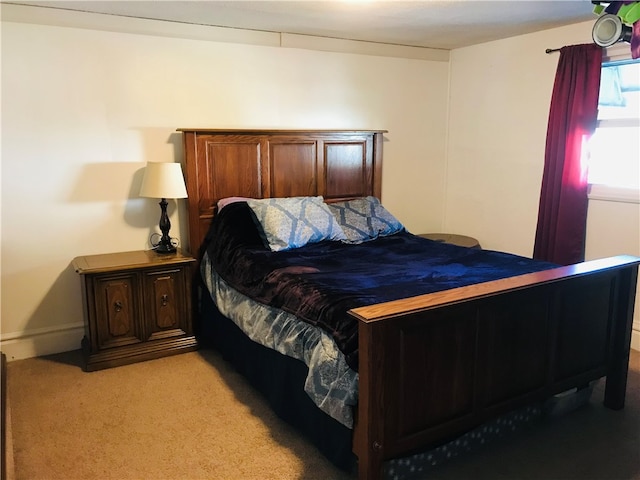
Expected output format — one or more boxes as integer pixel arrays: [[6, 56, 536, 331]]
[[0, 323, 84, 361]]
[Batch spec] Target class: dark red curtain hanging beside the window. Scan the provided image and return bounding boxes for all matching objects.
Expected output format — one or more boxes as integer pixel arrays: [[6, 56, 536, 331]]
[[533, 44, 602, 265]]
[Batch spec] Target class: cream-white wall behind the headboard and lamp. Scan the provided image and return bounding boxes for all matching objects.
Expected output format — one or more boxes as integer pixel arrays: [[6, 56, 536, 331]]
[[0, 15, 448, 359]]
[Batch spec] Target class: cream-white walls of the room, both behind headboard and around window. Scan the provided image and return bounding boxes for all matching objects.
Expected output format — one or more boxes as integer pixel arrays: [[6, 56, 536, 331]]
[[0, 10, 640, 359]]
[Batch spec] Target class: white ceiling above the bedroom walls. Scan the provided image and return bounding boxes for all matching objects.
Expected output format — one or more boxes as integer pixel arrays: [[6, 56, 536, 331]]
[[2, 0, 596, 50]]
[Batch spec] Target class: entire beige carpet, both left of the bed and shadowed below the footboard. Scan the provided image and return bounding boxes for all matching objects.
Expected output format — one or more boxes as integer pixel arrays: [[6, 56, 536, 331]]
[[8, 351, 640, 480]]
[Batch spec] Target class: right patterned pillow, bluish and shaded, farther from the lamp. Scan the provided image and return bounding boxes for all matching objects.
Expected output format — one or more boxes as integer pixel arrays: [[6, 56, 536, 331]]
[[329, 197, 404, 243]]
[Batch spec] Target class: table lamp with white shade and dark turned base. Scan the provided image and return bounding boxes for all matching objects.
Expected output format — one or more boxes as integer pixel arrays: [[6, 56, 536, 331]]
[[140, 162, 187, 253]]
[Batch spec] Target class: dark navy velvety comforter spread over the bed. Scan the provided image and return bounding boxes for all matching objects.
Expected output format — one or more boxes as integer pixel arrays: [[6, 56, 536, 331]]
[[206, 202, 556, 370]]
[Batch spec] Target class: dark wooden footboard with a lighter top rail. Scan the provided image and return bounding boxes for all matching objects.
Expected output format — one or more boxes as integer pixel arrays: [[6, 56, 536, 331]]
[[351, 256, 640, 480]]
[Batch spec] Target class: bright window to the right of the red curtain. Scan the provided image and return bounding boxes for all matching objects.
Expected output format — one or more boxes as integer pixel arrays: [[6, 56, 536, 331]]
[[587, 55, 640, 198]]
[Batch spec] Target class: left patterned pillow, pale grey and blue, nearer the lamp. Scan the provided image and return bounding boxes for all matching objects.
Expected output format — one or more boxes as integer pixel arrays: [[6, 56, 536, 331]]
[[247, 197, 346, 252]]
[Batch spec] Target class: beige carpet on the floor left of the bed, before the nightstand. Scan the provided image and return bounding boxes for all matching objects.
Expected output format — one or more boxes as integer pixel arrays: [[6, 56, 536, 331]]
[[8, 351, 344, 480]]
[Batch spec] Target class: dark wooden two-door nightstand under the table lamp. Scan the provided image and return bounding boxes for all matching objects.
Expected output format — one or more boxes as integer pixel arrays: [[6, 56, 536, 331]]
[[73, 250, 198, 371]]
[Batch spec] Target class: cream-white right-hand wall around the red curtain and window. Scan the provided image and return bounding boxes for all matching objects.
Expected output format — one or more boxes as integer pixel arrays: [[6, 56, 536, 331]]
[[444, 22, 640, 349]]
